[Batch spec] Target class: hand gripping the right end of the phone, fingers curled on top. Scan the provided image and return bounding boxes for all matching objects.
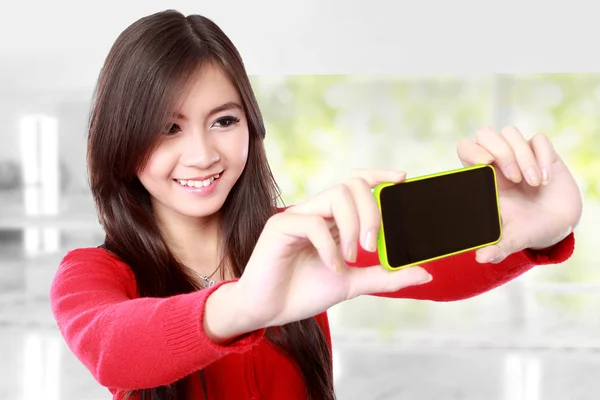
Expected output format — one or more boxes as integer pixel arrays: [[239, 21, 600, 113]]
[[457, 126, 583, 263]]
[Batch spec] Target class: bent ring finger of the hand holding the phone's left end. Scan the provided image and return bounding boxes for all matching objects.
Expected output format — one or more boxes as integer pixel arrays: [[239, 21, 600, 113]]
[[286, 185, 360, 262]]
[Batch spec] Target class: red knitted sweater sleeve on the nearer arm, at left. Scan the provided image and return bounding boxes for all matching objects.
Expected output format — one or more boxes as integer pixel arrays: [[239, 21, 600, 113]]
[[50, 249, 265, 390]]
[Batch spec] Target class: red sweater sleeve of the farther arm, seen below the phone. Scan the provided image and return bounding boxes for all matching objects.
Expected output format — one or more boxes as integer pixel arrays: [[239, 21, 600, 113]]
[[350, 233, 575, 301]]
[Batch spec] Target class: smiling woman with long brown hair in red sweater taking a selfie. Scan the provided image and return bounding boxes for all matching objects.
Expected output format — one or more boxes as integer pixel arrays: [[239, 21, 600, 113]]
[[51, 11, 581, 400]]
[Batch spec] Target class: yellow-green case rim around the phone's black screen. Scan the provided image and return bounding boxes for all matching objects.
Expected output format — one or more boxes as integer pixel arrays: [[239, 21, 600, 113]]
[[373, 164, 502, 271]]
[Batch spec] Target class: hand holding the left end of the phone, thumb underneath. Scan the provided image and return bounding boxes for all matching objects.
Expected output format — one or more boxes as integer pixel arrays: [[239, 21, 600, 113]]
[[229, 170, 431, 331]]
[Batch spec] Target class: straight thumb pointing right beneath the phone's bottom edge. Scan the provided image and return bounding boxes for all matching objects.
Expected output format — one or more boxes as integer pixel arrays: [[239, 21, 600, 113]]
[[347, 266, 432, 298]]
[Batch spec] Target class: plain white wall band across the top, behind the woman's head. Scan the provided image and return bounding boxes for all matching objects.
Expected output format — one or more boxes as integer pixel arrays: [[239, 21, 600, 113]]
[[0, 0, 600, 95]]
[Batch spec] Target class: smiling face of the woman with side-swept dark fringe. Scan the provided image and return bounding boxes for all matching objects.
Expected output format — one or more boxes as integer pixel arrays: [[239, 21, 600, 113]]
[[138, 65, 249, 218]]
